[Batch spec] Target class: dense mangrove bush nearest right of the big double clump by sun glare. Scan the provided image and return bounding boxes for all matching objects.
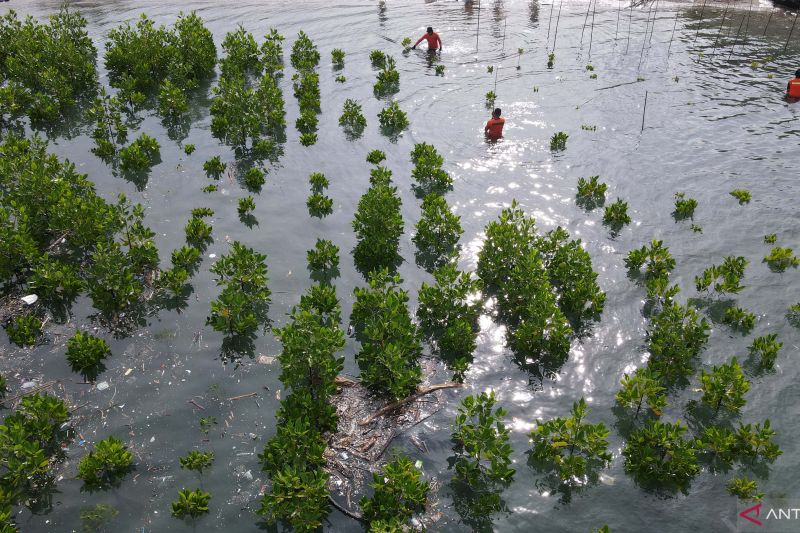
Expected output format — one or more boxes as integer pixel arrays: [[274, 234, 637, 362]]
[[647, 302, 709, 383]]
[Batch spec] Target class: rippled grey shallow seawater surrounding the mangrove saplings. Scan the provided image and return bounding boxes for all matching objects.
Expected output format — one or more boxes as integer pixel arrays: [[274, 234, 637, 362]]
[[0, 0, 800, 532]]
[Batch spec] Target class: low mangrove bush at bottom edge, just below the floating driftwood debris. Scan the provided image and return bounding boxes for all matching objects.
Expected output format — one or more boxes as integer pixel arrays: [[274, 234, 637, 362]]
[[360, 455, 430, 531]]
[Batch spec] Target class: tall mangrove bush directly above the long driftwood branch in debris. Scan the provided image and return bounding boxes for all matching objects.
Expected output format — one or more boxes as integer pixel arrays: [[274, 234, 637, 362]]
[[350, 268, 422, 400]]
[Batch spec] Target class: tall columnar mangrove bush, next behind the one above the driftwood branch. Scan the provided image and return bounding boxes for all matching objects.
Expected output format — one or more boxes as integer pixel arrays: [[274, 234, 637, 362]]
[[352, 176, 403, 273]]
